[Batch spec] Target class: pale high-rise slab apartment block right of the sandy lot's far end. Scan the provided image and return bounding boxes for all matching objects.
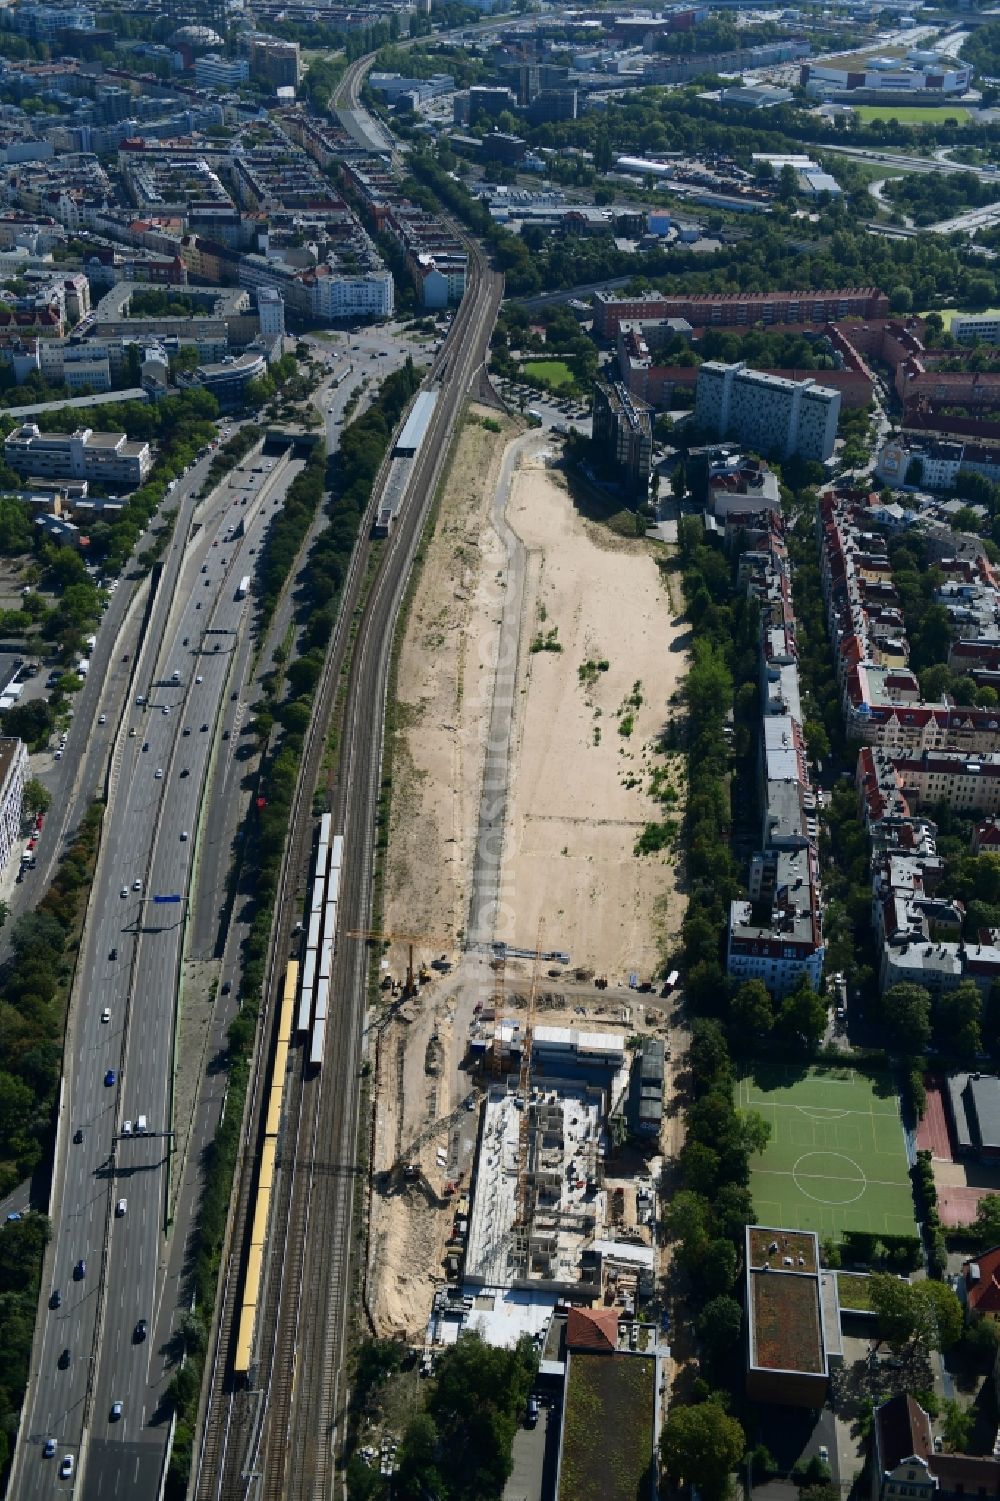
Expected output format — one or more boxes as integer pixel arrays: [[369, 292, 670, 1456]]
[[695, 360, 841, 462]]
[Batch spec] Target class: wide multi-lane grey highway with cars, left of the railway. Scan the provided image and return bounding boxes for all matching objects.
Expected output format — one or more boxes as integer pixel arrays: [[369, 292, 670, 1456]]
[[12, 458, 297, 1498]]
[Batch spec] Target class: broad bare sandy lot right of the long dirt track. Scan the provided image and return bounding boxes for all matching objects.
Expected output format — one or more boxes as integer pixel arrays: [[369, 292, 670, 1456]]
[[503, 462, 686, 980]]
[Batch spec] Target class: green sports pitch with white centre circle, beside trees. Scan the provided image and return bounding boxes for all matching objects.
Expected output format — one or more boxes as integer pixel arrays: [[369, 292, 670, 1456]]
[[736, 1064, 917, 1240]]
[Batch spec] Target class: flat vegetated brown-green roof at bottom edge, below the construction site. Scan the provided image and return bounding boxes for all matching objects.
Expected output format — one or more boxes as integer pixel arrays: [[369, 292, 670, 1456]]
[[559, 1354, 656, 1501]]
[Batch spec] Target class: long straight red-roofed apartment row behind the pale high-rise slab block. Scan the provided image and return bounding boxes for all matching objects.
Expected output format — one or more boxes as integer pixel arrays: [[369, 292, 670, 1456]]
[[593, 287, 889, 339]]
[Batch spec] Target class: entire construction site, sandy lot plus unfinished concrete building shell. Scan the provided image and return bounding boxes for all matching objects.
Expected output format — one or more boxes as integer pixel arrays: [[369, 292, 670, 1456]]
[[366, 420, 686, 1363]]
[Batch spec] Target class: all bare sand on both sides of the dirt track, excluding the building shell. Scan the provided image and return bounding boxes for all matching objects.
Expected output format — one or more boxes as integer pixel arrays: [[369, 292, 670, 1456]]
[[369, 420, 686, 1339]]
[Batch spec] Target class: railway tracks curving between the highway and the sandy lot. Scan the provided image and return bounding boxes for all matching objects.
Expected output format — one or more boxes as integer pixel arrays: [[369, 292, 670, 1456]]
[[192, 59, 502, 1501]]
